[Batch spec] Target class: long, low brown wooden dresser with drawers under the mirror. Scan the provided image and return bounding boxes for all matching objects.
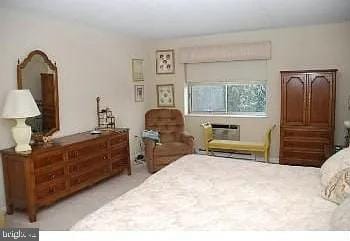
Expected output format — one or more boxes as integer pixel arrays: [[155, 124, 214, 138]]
[[1, 129, 131, 222]]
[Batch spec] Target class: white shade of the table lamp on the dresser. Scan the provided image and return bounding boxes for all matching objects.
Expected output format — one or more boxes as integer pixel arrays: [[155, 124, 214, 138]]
[[2, 90, 40, 119]]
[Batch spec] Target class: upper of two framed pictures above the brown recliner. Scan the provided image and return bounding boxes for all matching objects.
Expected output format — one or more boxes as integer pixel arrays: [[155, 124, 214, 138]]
[[156, 49, 175, 74]]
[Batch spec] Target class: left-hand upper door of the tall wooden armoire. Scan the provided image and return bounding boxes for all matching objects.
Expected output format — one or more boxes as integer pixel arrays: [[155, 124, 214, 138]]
[[281, 73, 307, 126]]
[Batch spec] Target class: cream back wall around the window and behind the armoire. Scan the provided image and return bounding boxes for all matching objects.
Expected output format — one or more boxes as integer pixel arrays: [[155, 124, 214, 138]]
[[147, 22, 350, 162]]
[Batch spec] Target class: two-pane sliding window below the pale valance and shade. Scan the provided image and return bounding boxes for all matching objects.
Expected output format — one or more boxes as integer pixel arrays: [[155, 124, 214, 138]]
[[188, 81, 266, 116]]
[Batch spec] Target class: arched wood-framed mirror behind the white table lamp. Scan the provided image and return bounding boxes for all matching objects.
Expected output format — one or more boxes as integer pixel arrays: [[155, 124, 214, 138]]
[[17, 50, 60, 137]]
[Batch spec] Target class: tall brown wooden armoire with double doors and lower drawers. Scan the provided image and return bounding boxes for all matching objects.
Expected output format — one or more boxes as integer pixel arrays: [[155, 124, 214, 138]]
[[280, 69, 337, 167]]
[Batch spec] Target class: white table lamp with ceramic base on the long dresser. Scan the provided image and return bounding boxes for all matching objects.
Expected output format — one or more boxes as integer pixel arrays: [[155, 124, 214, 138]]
[[2, 90, 40, 152]]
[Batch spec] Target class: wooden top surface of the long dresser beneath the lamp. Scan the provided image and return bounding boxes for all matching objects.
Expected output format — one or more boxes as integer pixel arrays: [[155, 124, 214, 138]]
[[1, 128, 129, 156]]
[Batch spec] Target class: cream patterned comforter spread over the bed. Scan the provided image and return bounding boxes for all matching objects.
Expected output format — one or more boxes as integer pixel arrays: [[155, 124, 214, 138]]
[[72, 155, 336, 231]]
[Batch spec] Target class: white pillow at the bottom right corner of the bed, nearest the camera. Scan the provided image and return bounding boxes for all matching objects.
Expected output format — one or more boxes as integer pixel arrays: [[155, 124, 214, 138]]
[[330, 198, 350, 231]]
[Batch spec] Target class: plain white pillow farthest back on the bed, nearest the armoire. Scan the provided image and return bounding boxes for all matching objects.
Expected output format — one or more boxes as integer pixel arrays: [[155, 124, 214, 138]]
[[321, 148, 350, 187]]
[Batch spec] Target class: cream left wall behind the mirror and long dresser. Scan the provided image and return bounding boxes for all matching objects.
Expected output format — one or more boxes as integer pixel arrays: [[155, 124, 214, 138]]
[[0, 9, 149, 207]]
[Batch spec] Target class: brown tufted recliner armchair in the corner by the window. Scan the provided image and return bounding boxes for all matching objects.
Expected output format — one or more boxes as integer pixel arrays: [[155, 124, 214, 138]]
[[144, 109, 194, 173]]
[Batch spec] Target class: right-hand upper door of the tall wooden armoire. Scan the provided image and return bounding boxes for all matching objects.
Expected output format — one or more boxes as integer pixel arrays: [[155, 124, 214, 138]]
[[307, 72, 335, 128]]
